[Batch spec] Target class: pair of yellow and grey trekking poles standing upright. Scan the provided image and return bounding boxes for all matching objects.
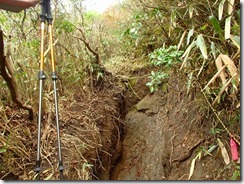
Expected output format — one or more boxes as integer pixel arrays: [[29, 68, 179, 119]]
[[35, 0, 64, 180]]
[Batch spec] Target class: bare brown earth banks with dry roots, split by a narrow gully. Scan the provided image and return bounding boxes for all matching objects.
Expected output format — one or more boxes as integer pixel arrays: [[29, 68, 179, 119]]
[[0, 66, 238, 180]]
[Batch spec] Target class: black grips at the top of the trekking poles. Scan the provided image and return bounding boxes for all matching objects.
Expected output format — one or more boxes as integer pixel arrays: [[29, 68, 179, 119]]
[[40, 0, 53, 24]]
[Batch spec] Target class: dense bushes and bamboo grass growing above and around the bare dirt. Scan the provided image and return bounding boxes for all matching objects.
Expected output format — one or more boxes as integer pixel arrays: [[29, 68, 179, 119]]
[[0, 0, 240, 180]]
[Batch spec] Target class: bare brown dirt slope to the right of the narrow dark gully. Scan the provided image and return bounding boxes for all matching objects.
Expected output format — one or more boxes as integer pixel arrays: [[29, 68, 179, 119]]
[[111, 71, 234, 180]]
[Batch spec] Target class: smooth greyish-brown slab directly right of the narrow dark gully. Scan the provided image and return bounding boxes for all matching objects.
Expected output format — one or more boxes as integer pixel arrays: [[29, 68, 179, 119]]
[[112, 94, 165, 180]]
